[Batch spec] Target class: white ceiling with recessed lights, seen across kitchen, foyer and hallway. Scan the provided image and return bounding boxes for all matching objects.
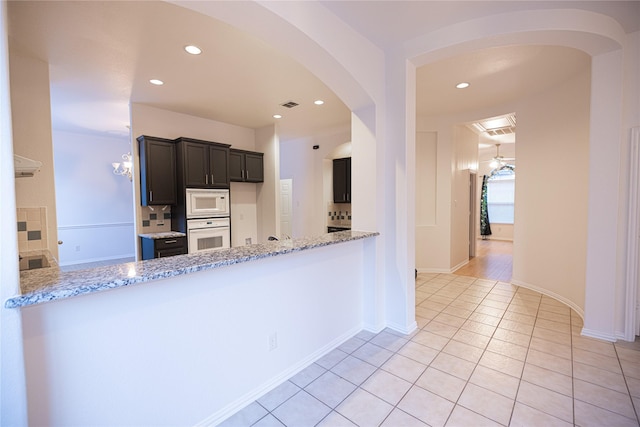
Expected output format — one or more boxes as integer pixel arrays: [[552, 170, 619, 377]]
[[8, 1, 640, 139]]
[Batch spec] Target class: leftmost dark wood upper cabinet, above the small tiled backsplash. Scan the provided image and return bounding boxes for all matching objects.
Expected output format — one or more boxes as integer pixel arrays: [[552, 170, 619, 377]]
[[138, 135, 177, 206]]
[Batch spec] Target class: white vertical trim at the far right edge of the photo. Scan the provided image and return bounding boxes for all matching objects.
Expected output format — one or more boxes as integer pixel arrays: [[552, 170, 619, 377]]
[[622, 127, 640, 341]]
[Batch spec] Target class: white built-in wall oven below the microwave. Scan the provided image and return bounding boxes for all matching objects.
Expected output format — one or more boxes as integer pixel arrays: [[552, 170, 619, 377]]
[[187, 218, 231, 254]]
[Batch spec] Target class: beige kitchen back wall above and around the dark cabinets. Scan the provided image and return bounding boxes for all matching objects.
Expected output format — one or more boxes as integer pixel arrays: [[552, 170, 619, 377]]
[[131, 103, 260, 254]]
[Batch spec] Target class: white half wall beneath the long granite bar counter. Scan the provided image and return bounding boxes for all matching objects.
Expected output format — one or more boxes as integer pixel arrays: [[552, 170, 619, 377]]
[[23, 238, 375, 426]]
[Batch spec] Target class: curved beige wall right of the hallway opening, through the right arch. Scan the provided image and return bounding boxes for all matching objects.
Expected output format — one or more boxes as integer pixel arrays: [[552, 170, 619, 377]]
[[513, 69, 591, 313]]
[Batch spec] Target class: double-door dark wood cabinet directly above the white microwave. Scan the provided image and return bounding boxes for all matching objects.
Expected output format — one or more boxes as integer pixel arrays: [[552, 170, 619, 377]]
[[176, 137, 230, 189]]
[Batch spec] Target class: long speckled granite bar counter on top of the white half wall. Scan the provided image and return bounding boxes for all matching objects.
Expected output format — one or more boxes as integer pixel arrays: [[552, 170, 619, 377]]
[[5, 231, 379, 308]]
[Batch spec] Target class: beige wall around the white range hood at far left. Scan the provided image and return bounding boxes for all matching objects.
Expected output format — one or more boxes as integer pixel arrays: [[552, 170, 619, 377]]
[[9, 45, 58, 257]]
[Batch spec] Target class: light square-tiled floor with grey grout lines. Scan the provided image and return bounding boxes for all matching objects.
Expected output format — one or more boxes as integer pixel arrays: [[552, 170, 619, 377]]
[[222, 274, 640, 427]]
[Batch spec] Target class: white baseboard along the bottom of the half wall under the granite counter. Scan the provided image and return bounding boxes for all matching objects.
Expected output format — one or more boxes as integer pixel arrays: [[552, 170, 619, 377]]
[[195, 327, 362, 427]]
